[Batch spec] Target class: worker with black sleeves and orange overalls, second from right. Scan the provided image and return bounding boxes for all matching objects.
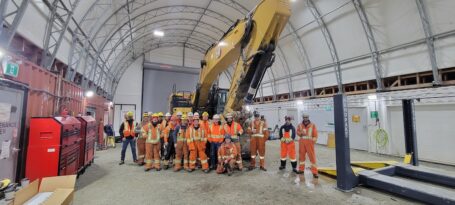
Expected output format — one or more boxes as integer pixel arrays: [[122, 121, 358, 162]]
[[279, 116, 298, 174]]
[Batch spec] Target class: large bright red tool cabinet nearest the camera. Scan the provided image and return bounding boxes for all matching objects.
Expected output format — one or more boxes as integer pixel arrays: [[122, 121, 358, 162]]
[[25, 117, 81, 181]]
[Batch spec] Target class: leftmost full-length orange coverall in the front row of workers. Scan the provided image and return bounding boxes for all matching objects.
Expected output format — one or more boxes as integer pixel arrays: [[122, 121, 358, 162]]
[[145, 123, 162, 170]]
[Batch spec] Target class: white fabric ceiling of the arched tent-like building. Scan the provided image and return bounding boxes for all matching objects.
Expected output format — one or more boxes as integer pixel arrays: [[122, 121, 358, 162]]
[[16, 0, 455, 96]]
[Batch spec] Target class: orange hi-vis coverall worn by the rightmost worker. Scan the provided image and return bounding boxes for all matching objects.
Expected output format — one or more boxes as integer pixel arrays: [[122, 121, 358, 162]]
[[297, 122, 318, 174]]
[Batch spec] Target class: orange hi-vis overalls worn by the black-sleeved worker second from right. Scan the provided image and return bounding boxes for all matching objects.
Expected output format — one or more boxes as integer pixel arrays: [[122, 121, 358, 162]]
[[280, 124, 297, 162]]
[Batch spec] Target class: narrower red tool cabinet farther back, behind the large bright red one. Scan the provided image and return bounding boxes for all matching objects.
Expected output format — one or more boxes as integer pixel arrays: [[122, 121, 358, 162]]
[[77, 116, 98, 169]]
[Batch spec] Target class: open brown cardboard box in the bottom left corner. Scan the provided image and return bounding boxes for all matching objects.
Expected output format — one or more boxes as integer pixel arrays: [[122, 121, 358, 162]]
[[14, 175, 76, 205]]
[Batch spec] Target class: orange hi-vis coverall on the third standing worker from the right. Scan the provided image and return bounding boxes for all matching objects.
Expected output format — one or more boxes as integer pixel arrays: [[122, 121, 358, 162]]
[[248, 120, 269, 168]]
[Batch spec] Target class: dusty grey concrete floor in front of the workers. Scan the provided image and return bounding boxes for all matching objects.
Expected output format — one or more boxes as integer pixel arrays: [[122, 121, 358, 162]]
[[74, 141, 455, 205]]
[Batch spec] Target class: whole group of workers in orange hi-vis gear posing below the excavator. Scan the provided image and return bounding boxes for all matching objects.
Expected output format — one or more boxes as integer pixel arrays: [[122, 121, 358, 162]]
[[119, 109, 318, 177]]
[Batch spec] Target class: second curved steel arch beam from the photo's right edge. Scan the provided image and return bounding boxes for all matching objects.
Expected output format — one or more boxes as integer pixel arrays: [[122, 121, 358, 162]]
[[352, 0, 384, 91]]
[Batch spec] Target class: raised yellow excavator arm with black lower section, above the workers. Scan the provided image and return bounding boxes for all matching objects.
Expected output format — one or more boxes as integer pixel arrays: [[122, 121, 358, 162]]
[[193, 0, 291, 113]]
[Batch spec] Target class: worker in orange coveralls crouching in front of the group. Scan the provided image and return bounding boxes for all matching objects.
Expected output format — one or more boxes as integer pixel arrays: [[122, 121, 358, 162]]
[[216, 134, 237, 176]]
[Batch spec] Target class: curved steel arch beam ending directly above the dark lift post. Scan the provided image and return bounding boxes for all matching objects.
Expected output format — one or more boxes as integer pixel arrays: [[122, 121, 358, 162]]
[[307, 0, 343, 93]]
